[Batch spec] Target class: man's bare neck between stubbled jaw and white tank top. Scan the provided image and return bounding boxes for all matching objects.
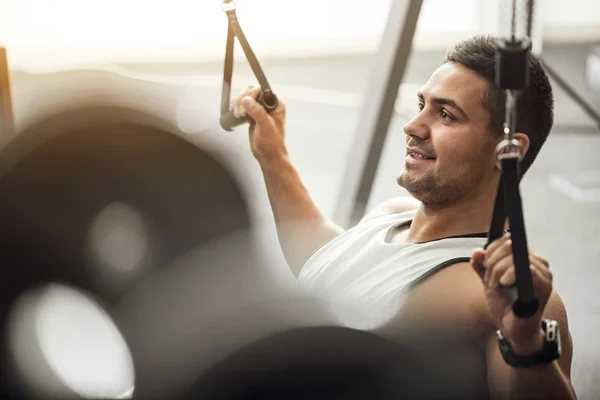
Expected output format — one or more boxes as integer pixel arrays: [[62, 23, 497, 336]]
[[408, 180, 497, 242]]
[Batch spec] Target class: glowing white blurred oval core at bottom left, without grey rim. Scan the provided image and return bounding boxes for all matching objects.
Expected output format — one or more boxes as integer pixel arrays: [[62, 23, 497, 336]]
[[37, 285, 134, 399]]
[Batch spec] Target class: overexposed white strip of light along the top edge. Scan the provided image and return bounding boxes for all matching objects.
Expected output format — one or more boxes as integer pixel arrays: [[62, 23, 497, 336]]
[[0, 0, 486, 68]]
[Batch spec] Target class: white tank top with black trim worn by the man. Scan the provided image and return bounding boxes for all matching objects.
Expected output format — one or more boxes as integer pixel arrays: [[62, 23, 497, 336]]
[[298, 211, 487, 329]]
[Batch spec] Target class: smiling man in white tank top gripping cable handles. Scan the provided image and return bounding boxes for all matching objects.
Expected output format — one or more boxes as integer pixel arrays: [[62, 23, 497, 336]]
[[233, 37, 575, 399]]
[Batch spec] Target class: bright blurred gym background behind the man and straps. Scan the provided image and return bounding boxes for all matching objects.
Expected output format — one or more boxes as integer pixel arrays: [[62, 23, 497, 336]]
[[0, 0, 600, 400]]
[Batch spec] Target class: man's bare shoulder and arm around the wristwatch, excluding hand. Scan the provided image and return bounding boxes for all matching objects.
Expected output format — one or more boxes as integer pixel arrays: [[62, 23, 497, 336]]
[[406, 263, 576, 400]]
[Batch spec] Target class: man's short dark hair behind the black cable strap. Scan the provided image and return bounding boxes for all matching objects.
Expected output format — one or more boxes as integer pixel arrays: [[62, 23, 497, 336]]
[[444, 35, 554, 177]]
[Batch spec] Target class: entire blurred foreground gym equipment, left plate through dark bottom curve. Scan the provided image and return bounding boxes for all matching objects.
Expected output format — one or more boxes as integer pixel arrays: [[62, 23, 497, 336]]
[[0, 66, 450, 399]]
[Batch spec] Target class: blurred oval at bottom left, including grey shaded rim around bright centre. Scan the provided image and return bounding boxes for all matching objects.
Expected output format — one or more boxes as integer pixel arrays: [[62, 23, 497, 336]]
[[8, 284, 134, 399]]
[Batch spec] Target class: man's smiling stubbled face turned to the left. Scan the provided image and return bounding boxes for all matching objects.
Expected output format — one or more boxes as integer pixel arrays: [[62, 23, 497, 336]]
[[398, 64, 498, 207]]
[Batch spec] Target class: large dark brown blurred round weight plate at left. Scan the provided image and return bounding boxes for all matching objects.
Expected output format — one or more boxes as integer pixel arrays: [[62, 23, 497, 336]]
[[0, 67, 252, 399]]
